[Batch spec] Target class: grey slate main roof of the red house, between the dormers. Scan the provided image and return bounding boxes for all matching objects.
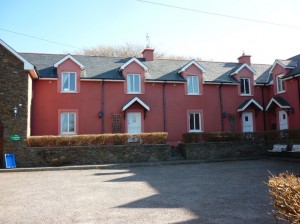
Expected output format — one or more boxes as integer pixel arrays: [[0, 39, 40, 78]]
[[21, 53, 271, 83]]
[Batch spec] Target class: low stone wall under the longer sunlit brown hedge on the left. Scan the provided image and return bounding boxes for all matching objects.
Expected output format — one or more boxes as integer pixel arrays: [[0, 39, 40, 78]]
[[26, 144, 171, 167]]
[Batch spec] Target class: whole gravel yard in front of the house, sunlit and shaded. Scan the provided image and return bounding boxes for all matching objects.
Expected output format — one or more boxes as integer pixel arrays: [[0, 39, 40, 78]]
[[0, 160, 300, 224]]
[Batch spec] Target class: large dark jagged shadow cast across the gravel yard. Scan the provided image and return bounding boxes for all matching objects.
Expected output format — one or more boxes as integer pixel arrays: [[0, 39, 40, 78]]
[[95, 160, 300, 224]]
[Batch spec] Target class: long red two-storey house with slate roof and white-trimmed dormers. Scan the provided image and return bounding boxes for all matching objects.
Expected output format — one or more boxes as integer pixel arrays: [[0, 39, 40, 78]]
[[0, 39, 300, 145]]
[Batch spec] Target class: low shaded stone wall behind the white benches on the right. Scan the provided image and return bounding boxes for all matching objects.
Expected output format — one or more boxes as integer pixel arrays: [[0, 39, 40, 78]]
[[179, 140, 300, 160]]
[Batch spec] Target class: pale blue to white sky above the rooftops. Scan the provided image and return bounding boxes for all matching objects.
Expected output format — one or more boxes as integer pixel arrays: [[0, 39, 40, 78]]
[[0, 0, 300, 64]]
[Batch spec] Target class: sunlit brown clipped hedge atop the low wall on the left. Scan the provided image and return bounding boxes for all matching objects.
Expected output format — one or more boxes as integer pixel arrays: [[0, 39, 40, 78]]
[[27, 132, 168, 147]]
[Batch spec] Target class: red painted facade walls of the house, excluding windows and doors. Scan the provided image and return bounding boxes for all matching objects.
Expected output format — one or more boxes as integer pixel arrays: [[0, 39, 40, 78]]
[[32, 57, 300, 144]]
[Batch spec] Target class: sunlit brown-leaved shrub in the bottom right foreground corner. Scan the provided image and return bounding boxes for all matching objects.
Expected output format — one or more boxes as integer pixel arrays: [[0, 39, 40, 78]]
[[268, 173, 300, 224]]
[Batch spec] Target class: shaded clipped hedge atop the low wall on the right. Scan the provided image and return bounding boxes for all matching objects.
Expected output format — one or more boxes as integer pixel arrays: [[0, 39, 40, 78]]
[[182, 129, 300, 143]]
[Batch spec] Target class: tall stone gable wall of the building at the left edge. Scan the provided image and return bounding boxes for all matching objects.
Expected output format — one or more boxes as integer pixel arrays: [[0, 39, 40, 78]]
[[0, 45, 30, 167]]
